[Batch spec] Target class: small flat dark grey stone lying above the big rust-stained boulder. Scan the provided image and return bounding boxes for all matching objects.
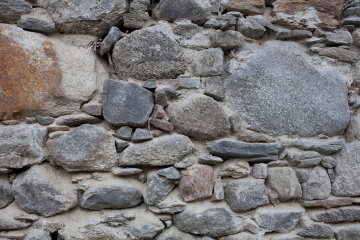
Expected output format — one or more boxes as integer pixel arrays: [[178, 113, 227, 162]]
[[16, 18, 55, 34]]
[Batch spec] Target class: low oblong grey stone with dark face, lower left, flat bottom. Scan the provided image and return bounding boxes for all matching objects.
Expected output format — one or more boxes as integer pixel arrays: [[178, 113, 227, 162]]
[[80, 184, 143, 210]]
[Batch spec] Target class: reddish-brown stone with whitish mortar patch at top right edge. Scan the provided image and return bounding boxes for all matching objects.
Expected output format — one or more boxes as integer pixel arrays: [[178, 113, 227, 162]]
[[272, 0, 344, 29]]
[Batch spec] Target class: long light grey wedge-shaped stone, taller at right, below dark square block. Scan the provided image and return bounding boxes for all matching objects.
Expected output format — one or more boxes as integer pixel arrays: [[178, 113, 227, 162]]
[[119, 134, 194, 166]]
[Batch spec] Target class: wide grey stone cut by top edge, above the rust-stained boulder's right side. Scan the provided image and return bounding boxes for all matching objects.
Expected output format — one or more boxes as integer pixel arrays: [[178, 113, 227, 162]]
[[42, 0, 129, 36]]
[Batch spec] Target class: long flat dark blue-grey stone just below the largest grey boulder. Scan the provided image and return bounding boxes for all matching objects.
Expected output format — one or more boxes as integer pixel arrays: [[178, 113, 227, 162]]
[[207, 140, 282, 162]]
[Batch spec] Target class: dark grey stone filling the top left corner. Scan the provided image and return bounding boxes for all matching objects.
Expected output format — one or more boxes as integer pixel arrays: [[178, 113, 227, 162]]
[[0, 0, 32, 24]]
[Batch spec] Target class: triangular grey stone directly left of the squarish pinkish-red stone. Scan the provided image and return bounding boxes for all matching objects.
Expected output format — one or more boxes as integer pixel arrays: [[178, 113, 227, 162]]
[[145, 171, 175, 205]]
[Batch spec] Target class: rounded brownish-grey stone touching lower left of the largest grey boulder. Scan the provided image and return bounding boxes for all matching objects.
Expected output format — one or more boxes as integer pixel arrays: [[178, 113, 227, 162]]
[[167, 94, 230, 140]]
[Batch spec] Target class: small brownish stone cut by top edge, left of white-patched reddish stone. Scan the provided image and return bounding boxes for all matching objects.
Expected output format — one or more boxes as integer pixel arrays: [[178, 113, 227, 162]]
[[226, 0, 265, 15]]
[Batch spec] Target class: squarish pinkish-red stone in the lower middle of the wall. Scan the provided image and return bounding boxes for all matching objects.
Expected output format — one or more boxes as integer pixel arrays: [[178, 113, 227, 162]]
[[179, 166, 215, 202]]
